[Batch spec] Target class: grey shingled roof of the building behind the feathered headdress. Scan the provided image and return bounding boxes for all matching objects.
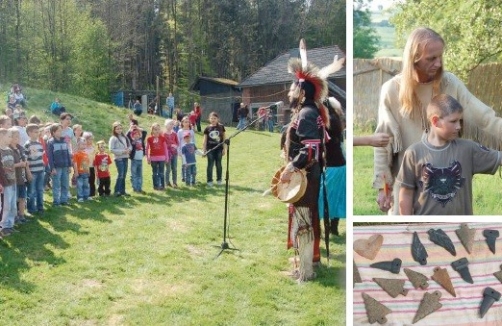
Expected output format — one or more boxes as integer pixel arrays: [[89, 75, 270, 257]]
[[239, 45, 346, 87]]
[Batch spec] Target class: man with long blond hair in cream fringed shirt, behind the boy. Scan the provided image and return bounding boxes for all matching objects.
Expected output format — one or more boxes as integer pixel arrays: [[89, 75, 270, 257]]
[[373, 27, 502, 215]]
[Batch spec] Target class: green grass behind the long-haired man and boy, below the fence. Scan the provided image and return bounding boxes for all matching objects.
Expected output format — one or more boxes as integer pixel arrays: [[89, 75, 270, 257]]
[[352, 130, 502, 215]]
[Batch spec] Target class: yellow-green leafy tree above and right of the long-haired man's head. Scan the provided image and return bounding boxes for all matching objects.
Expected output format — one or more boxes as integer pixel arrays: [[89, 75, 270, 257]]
[[391, 0, 502, 79]]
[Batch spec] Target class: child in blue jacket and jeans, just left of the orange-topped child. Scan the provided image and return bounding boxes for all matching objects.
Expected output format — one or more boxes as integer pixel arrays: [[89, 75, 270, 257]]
[[47, 123, 73, 206]]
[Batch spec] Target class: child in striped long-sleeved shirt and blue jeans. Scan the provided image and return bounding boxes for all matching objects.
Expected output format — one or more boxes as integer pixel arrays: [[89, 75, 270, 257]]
[[24, 123, 45, 214]]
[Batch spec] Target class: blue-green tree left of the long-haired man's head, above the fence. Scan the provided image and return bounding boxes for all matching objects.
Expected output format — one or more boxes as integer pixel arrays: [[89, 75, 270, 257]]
[[353, 6, 380, 59]]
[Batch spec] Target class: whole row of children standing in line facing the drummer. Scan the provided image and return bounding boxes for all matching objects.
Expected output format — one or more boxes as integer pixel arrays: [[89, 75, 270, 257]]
[[0, 112, 225, 236]]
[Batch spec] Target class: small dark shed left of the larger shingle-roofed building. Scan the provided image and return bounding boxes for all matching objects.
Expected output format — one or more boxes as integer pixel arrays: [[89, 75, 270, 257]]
[[191, 76, 241, 126]]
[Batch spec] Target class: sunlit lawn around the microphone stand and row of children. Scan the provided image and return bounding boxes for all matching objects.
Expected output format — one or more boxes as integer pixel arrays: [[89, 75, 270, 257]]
[[0, 86, 346, 325]]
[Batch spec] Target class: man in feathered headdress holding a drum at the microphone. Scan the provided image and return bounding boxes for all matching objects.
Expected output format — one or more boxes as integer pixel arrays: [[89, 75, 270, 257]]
[[280, 40, 329, 282]]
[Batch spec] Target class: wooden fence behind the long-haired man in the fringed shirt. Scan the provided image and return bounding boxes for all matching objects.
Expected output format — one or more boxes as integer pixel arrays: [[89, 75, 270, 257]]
[[353, 58, 502, 130]]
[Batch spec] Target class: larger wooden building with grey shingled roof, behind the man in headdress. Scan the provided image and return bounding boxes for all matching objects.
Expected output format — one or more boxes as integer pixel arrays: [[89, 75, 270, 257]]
[[238, 45, 347, 125]]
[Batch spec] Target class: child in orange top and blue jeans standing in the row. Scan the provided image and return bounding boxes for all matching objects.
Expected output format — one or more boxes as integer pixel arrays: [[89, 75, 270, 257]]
[[73, 138, 91, 203]]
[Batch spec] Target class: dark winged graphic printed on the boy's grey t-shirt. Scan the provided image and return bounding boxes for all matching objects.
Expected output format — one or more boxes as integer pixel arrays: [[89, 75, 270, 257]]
[[420, 161, 465, 207]]
